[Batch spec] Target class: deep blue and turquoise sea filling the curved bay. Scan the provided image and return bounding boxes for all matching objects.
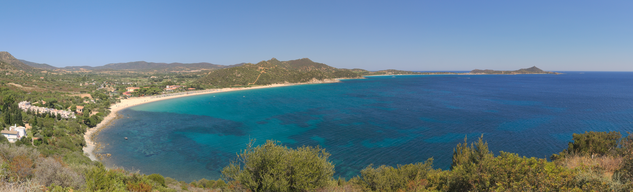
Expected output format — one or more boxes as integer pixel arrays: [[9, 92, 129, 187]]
[[98, 72, 633, 181]]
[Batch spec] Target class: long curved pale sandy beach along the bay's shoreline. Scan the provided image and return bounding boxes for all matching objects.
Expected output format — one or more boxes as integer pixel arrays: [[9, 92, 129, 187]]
[[83, 79, 340, 161]]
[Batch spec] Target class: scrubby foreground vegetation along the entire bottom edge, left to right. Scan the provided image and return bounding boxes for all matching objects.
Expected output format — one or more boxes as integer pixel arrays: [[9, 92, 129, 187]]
[[0, 132, 633, 191]]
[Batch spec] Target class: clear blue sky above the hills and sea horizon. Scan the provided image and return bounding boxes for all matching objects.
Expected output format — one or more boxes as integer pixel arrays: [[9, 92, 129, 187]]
[[0, 0, 633, 71]]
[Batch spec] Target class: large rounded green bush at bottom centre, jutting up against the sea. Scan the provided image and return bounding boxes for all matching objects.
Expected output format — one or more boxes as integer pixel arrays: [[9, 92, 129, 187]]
[[221, 141, 334, 191]]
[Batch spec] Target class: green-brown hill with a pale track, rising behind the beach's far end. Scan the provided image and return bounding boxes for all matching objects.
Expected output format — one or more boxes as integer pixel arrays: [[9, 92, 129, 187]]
[[197, 58, 361, 87]]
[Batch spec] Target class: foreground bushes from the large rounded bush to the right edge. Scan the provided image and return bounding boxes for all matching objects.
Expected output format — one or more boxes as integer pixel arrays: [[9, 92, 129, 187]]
[[216, 132, 633, 191]]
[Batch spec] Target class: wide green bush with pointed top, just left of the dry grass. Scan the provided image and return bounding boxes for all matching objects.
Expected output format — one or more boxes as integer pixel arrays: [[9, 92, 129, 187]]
[[428, 138, 576, 191]]
